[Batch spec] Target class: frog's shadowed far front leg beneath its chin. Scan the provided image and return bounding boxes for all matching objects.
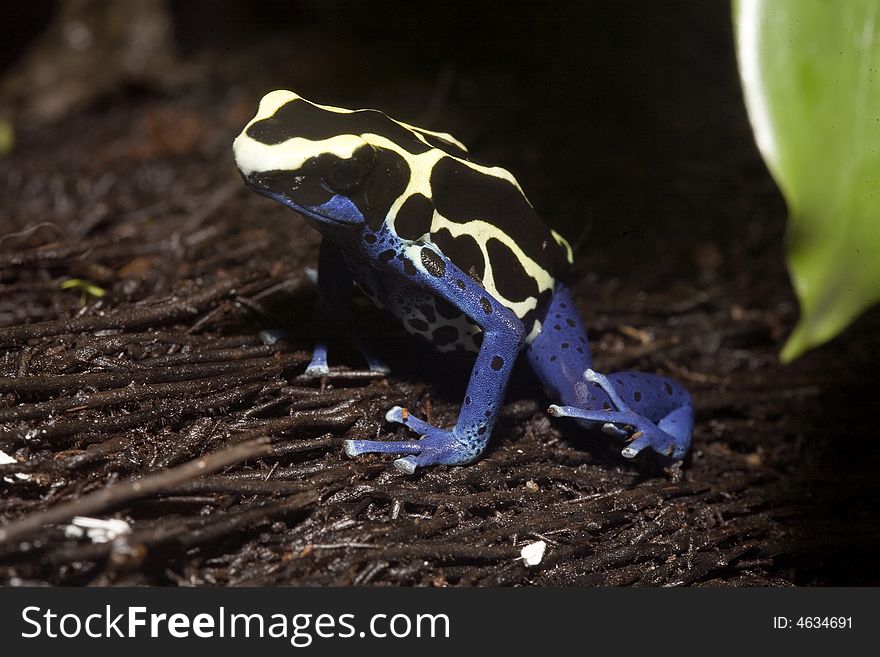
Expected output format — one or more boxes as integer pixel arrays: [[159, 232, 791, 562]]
[[305, 239, 389, 376]]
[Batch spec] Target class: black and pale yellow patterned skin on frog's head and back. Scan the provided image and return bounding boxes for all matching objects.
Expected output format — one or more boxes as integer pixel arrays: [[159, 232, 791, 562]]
[[235, 91, 572, 335]]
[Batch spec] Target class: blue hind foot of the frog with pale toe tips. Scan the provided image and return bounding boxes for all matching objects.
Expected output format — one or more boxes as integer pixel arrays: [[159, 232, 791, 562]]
[[549, 369, 692, 460]]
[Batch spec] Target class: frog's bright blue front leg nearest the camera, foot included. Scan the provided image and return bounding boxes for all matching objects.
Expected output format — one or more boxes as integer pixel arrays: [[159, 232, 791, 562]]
[[345, 246, 525, 474]]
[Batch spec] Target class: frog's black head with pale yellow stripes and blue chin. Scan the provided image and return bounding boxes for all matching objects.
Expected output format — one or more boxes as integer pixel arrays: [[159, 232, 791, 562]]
[[233, 91, 464, 228]]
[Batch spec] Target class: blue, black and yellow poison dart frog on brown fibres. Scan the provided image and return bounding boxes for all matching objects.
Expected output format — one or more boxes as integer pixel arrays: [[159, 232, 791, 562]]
[[233, 91, 693, 474]]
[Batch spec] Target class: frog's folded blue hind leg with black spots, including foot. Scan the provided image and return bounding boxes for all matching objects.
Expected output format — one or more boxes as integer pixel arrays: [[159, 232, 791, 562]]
[[526, 285, 693, 459]]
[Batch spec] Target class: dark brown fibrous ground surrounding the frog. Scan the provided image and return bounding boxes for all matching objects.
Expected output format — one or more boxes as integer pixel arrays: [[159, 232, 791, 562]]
[[0, 2, 880, 586]]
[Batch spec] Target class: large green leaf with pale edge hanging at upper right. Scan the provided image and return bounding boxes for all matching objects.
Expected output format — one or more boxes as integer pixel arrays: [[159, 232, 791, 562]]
[[734, 0, 880, 361]]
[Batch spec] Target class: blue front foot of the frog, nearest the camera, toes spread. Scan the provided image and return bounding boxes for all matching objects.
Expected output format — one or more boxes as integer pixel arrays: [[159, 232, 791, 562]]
[[343, 406, 480, 474]]
